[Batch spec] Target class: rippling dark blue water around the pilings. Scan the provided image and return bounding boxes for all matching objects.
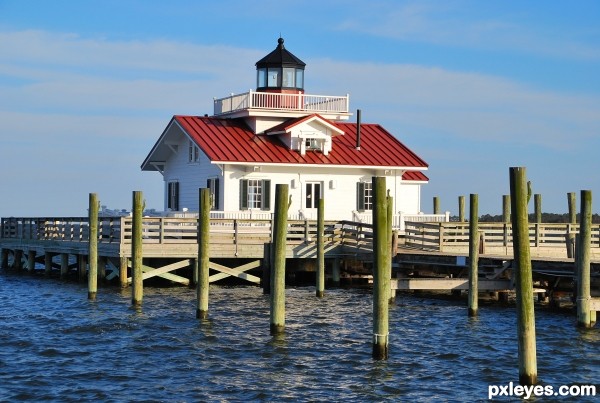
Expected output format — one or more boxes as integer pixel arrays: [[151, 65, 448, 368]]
[[0, 273, 600, 402]]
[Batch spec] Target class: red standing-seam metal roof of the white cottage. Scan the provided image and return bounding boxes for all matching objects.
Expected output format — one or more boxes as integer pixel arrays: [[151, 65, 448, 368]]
[[173, 115, 428, 181]]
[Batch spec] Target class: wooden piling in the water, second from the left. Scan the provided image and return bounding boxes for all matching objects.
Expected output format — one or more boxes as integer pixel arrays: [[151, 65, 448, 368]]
[[131, 190, 144, 306]]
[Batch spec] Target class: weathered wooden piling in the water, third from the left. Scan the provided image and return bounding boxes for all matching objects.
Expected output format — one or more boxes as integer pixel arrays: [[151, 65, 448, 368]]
[[196, 188, 210, 319]]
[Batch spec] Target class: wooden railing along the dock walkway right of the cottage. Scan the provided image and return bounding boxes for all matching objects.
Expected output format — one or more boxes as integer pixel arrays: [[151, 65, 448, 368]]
[[405, 221, 600, 257]]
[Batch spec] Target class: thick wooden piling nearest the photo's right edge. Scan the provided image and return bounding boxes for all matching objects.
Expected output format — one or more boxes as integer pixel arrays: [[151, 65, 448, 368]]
[[577, 190, 592, 328]]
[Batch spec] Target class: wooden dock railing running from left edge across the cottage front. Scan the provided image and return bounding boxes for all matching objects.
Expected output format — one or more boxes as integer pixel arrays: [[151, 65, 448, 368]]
[[0, 217, 372, 250]]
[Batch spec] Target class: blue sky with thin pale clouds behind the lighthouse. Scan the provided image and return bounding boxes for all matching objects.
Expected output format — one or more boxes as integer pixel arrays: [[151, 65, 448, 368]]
[[0, 0, 600, 217]]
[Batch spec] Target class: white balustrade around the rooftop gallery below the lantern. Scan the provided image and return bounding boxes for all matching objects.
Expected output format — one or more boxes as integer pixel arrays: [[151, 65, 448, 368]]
[[214, 91, 350, 115]]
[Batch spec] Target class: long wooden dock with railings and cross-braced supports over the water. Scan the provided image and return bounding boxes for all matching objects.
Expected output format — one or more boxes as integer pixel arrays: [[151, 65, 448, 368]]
[[0, 217, 600, 302]]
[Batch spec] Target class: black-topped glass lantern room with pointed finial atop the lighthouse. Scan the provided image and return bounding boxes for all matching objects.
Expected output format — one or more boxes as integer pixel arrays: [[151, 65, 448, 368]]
[[256, 38, 306, 94]]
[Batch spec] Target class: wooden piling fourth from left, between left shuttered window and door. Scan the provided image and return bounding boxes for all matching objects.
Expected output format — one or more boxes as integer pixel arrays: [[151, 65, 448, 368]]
[[270, 184, 289, 335]]
